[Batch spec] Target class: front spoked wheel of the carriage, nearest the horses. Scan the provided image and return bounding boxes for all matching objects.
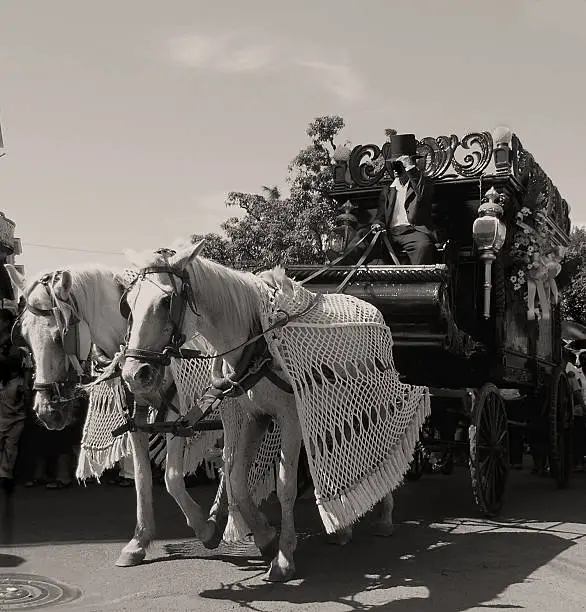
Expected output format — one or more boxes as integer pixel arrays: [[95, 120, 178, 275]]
[[469, 383, 509, 517]]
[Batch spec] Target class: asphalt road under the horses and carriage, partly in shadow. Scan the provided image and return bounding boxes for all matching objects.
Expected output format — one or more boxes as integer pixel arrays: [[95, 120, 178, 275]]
[[0, 468, 586, 612]]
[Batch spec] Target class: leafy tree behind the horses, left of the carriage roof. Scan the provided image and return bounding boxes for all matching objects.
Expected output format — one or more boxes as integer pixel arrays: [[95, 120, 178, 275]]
[[194, 116, 344, 269]]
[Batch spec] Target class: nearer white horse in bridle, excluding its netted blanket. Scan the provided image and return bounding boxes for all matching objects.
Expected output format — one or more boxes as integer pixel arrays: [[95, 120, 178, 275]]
[[122, 241, 393, 582]]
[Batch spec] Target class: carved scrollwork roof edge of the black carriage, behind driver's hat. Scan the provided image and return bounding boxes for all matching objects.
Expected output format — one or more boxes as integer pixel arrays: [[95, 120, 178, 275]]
[[332, 127, 570, 244]]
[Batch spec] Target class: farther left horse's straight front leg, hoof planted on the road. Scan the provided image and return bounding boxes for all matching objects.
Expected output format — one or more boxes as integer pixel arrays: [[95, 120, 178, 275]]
[[116, 431, 155, 567]]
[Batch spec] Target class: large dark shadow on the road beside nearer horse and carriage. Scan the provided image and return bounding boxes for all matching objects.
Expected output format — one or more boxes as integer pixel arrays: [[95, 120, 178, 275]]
[[200, 525, 574, 612]]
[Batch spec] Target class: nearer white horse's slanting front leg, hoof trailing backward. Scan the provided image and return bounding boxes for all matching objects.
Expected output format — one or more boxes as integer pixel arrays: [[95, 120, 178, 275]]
[[224, 415, 277, 561]]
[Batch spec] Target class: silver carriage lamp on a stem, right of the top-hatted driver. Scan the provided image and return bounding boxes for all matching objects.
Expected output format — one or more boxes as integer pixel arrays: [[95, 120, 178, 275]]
[[472, 187, 507, 319]]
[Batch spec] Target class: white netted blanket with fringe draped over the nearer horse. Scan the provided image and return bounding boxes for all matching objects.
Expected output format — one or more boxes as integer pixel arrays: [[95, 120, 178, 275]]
[[260, 279, 430, 533]]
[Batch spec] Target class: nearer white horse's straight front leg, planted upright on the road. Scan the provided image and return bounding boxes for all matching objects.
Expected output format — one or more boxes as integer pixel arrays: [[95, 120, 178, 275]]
[[264, 410, 301, 582]]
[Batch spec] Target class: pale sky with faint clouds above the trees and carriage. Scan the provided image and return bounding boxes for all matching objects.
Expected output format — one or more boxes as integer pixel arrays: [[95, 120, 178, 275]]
[[0, 0, 586, 274]]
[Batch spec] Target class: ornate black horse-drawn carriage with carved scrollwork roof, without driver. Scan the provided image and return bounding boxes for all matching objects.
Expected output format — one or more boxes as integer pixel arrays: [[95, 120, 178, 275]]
[[287, 128, 572, 515]]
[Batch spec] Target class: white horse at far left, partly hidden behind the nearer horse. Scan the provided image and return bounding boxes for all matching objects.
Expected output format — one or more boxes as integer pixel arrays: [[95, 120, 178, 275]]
[[6, 264, 227, 567]]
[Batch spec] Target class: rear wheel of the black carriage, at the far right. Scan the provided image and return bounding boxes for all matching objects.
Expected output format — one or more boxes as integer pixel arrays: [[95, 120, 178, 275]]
[[549, 369, 574, 489]]
